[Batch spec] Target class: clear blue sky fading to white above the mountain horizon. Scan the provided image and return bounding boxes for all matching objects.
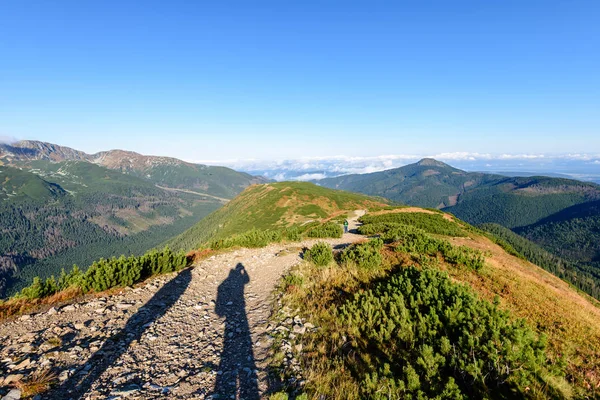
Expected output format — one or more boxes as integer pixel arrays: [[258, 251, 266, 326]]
[[0, 0, 600, 160]]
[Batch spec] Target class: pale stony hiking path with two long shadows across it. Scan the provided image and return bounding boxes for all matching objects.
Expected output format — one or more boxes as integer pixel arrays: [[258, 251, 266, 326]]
[[0, 211, 364, 399]]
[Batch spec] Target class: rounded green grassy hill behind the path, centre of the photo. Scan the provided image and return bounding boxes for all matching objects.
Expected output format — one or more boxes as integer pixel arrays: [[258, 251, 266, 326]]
[[168, 182, 385, 250]]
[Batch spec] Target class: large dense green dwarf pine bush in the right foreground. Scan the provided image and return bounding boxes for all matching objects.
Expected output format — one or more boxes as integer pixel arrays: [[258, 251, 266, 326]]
[[338, 267, 546, 399]]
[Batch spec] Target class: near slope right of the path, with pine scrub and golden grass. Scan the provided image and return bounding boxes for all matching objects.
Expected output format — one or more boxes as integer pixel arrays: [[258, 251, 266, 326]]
[[272, 208, 600, 399]]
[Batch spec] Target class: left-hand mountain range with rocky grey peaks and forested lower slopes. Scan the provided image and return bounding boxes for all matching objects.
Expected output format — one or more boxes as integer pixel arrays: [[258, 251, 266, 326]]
[[0, 141, 265, 297]]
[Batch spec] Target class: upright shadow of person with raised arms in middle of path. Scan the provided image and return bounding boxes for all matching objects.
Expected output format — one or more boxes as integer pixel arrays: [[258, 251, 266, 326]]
[[213, 263, 260, 400]]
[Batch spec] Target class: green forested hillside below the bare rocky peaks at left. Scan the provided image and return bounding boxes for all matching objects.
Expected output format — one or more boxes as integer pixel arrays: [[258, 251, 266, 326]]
[[0, 161, 222, 295]]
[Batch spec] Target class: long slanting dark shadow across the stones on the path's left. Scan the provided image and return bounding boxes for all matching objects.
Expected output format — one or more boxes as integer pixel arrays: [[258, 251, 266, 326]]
[[44, 268, 192, 399]]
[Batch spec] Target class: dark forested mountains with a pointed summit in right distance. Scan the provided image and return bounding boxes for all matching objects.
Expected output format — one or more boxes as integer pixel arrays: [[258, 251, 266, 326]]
[[315, 158, 600, 266]]
